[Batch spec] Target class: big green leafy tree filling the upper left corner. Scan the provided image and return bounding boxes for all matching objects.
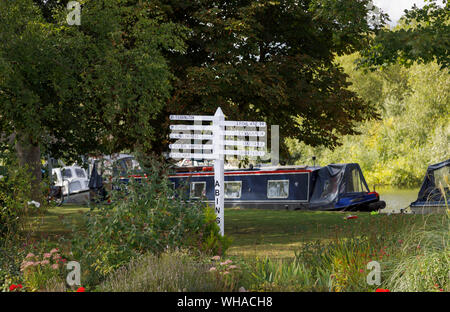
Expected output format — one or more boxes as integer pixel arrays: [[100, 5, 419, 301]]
[[0, 0, 183, 199]]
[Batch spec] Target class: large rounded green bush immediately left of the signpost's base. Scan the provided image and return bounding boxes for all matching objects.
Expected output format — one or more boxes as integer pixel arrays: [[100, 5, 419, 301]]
[[72, 163, 234, 283]]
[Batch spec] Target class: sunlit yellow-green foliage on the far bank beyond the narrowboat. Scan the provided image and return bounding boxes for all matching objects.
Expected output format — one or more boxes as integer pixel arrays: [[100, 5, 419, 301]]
[[287, 55, 450, 187]]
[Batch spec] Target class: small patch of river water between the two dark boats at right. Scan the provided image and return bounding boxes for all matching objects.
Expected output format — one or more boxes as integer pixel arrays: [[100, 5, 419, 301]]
[[376, 186, 419, 213]]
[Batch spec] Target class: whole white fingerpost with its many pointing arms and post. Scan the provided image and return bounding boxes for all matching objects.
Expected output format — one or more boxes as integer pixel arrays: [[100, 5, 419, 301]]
[[169, 107, 266, 236]]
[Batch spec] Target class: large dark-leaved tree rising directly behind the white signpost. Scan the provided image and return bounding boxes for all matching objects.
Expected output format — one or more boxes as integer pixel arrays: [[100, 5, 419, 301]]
[[146, 0, 385, 156]]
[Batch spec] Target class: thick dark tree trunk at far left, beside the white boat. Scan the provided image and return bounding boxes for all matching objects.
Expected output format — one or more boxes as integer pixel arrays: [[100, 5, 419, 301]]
[[15, 135, 43, 203]]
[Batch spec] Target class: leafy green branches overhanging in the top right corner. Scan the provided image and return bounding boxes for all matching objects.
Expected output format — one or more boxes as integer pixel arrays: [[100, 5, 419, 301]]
[[359, 0, 450, 69]]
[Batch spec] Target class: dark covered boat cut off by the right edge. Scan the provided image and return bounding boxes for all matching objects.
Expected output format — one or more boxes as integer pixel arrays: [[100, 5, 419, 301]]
[[410, 159, 450, 214]]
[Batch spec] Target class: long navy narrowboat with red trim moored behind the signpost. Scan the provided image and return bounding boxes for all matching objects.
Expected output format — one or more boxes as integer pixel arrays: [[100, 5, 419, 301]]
[[169, 163, 386, 211]]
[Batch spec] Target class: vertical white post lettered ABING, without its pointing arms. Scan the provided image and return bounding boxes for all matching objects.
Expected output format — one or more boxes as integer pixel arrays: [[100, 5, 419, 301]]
[[213, 107, 225, 236]]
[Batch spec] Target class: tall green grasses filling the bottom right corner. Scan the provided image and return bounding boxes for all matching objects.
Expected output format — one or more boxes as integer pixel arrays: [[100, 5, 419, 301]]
[[248, 211, 450, 292]]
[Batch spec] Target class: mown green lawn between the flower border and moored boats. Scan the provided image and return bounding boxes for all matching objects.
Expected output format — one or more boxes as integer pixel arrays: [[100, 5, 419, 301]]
[[27, 205, 438, 258]]
